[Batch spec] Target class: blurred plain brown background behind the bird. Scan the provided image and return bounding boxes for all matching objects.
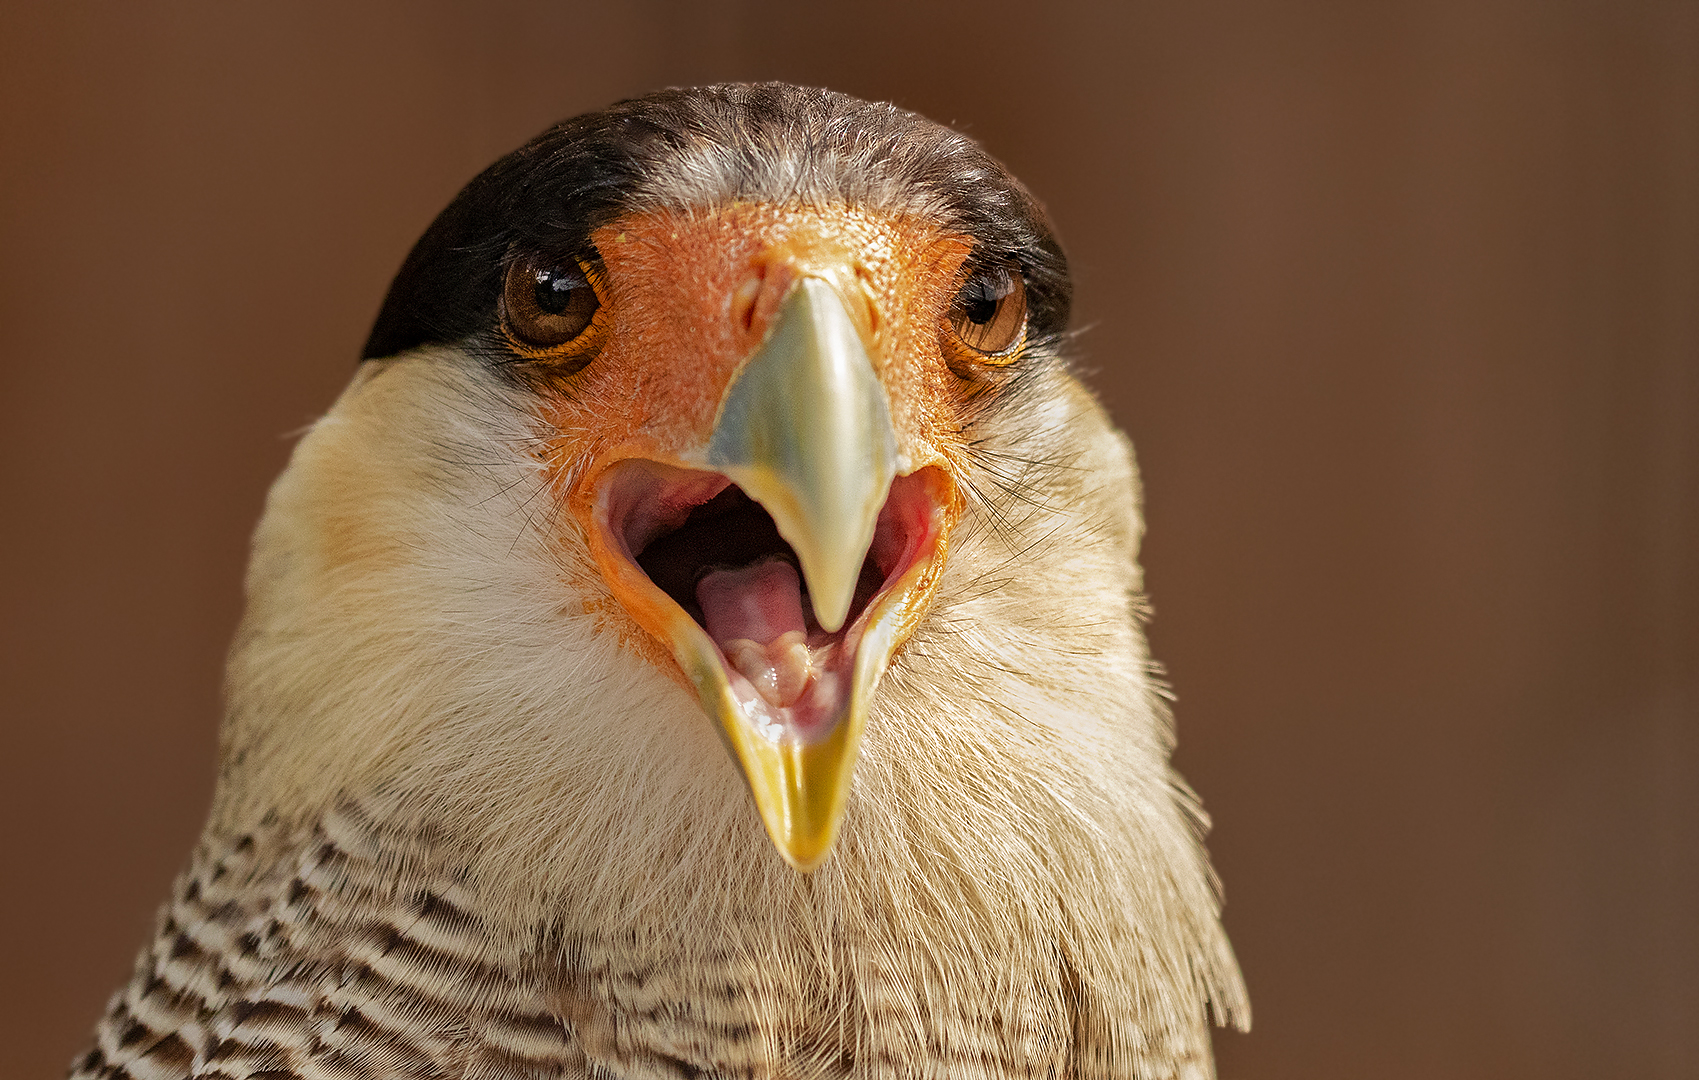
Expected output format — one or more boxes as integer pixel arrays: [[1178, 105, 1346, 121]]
[[0, 0, 1699, 1080]]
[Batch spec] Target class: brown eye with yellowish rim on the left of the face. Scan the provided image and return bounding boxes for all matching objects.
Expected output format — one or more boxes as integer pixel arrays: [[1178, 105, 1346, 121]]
[[501, 256, 607, 362]]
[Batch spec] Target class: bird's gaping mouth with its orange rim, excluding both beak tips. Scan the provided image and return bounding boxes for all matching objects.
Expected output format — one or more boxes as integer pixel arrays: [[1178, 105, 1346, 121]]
[[593, 458, 950, 744]]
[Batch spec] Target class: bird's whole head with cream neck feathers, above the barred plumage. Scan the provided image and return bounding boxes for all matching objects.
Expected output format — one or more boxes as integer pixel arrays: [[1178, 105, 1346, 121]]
[[209, 85, 1244, 1053]]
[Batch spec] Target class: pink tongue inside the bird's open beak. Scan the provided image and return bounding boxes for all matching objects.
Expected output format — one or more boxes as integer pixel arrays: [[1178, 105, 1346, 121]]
[[697, 557, 812, 706]]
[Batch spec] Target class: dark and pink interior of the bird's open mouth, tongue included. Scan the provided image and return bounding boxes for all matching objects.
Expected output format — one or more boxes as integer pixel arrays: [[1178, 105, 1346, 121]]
[[605, 460, 938, 739]]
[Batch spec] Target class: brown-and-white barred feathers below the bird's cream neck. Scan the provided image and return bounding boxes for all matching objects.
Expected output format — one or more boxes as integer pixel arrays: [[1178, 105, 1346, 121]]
[[71, 807, 1210, 1080]]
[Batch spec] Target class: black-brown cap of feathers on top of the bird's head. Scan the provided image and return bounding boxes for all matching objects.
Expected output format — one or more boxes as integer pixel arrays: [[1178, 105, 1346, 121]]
[[362, 83, 1072, 358]]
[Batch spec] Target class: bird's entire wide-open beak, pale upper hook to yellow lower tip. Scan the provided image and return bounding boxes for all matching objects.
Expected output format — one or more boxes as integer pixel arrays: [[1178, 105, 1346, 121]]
[[586, 275, 960, 869]]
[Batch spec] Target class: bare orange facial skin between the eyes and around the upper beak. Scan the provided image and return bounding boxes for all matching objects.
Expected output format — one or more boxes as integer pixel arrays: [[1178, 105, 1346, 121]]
[[553, 204, 972, 667]]
